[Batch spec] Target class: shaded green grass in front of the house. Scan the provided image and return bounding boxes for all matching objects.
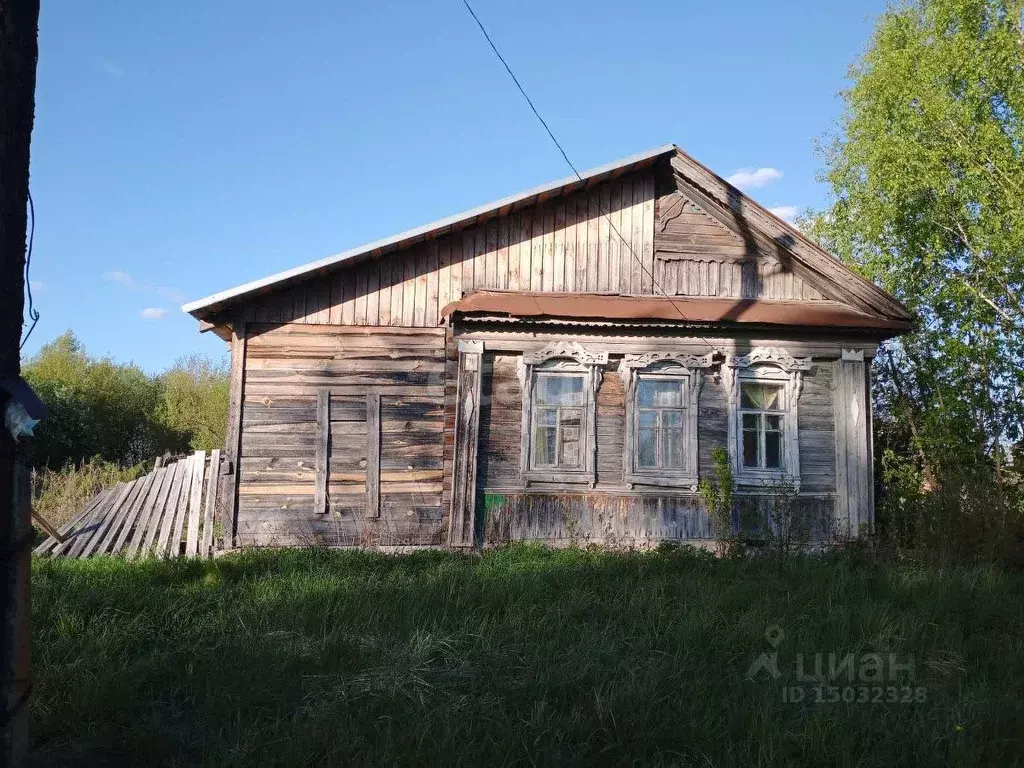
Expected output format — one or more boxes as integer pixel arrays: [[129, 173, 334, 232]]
[[32, 547, 1024, 766]]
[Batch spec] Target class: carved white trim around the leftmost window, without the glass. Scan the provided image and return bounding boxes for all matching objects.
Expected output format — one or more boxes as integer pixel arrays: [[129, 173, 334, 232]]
[[518, 341, 608, 487]]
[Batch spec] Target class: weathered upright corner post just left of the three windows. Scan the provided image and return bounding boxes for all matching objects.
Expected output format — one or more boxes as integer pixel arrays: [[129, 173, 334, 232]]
[[449, 341, 483, 547]]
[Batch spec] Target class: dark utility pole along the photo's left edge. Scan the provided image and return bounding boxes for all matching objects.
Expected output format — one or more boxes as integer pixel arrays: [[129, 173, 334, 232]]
[[0, 0, 39, 766]]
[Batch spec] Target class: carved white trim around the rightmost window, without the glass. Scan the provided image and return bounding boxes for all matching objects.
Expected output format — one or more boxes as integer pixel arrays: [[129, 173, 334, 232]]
[[722, 347, 812, 490]]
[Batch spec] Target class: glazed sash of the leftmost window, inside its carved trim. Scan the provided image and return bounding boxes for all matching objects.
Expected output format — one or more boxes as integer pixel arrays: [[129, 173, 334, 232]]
[[530, 373, 587, 469]]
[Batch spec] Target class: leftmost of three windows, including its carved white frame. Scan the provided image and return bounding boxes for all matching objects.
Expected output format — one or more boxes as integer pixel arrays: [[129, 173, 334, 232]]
[[519, 341, 608, 486]]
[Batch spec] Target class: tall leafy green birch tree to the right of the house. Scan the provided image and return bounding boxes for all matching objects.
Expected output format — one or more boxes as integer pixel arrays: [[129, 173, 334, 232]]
[[810, 0, 1024, 482]]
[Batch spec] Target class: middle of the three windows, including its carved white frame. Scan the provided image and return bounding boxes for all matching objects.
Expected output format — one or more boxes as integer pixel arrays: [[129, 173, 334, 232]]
[[618, 351, 714, 490]]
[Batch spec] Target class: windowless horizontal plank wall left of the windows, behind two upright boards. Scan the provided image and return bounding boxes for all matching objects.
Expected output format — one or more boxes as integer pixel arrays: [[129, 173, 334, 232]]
[[238, 325, 447, 546]]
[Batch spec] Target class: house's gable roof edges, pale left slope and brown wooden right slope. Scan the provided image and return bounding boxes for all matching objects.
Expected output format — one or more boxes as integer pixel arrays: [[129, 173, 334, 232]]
[[181, 144, 912, 324]]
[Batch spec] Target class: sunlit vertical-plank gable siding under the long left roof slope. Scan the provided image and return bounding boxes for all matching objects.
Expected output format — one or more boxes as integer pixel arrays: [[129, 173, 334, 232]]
[[240, 171, 654, 328]]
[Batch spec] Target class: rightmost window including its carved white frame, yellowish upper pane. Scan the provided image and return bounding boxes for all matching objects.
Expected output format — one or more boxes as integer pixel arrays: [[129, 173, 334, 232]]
[[722, 348, 811, 488]]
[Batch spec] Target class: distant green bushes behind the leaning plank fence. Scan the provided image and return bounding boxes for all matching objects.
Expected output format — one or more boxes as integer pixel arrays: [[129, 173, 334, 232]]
[[24, 331, 227, 469]]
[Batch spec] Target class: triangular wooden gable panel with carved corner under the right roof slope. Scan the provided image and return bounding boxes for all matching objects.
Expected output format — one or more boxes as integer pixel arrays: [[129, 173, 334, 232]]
[[654, 191, 824, 301]]
